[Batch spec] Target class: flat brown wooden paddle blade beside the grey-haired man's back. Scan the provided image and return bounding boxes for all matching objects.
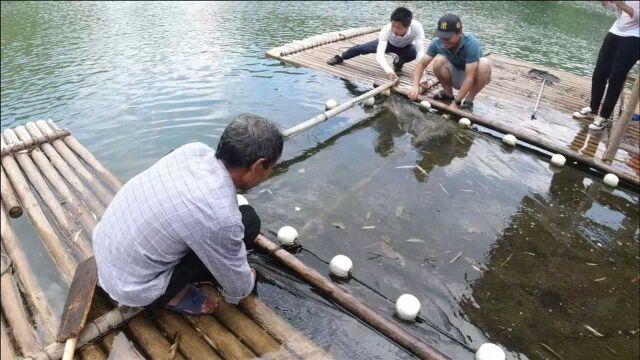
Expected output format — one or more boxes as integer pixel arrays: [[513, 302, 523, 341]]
[[56, 256, 98, 342]]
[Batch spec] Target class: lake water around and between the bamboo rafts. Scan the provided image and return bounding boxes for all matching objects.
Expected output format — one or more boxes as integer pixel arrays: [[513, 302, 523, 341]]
[[0, 2, 640, 359]]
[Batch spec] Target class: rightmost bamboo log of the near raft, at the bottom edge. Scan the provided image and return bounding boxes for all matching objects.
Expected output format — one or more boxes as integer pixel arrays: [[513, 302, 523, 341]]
[[239, 295, 331, 360]]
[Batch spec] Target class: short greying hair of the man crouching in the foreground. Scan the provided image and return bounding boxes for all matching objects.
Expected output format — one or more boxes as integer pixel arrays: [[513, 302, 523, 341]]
[[216, 114, 284, 168]]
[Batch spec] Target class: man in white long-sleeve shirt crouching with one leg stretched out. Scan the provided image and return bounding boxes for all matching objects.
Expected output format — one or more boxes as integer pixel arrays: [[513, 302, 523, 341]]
[[327, 7, 424, 80]]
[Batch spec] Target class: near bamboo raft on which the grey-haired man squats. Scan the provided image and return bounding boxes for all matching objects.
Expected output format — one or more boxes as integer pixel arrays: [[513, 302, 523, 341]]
[[0, 120, 330, 360]]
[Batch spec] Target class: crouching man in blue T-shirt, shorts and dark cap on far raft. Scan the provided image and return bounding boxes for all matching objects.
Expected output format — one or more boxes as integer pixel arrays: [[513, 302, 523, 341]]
[[409, 14, 491, 112]]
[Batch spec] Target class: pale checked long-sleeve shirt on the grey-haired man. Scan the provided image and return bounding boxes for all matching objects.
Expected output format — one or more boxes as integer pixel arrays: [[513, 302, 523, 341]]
[[93, 143, 254, 306]]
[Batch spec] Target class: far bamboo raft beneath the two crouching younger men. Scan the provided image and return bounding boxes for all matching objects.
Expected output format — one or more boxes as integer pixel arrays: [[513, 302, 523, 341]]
[[266, 27, 640, 186]]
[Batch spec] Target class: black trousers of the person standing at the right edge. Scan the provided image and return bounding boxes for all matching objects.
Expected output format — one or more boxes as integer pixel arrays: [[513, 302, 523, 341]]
[[591, 32, 640, 119]]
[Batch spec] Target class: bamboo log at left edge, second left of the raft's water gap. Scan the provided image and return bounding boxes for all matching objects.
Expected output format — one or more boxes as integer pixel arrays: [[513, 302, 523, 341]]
[[0, 248, 41, 354]]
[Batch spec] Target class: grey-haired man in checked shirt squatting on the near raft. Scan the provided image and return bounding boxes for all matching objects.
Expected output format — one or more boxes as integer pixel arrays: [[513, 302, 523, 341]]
[[93, 115, 283, 315]]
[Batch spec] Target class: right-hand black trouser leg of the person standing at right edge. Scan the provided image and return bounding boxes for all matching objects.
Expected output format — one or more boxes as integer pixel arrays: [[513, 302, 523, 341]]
[[600, 36, 640, 119]]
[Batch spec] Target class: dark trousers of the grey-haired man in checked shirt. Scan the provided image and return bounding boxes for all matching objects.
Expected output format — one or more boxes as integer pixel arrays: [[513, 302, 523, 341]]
[[149, 205, 260, 307]]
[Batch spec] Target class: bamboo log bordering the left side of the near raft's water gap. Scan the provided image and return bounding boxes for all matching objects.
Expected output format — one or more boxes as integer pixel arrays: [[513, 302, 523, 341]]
[[0, 207, 58, 342]]
